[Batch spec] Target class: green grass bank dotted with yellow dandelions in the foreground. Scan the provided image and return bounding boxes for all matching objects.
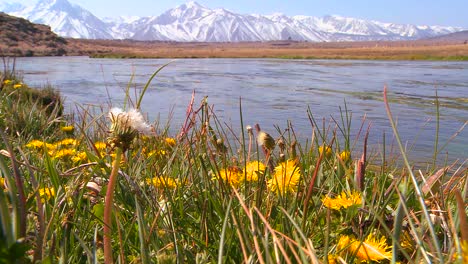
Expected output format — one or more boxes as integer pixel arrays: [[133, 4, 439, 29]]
[[0, 72, 468, 263]]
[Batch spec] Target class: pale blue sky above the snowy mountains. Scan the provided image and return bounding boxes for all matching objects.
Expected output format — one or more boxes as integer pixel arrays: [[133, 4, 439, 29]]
[[0, 0, 468, 29]]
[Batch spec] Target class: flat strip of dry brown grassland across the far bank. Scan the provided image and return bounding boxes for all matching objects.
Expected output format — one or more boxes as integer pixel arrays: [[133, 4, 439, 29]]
[[67, 39, 468, 60]]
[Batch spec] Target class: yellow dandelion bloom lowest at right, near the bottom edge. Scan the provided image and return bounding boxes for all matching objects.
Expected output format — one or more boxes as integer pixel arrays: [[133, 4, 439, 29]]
[[337, 234, 392, 262]]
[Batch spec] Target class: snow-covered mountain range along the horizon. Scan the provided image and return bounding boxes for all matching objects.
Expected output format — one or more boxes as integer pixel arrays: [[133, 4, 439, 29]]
[[0, 0, 463, 42]]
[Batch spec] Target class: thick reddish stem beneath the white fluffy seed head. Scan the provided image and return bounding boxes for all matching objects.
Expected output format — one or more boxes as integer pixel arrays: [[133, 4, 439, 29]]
[[104, 147, 122, 264]]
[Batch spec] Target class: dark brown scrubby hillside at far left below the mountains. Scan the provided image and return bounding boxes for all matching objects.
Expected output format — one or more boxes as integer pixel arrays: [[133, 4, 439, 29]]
[[0, 12, 67, 56]]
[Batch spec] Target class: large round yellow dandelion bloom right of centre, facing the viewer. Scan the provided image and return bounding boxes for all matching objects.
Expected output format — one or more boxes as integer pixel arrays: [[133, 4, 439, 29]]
[[268, 160, 301, 195]]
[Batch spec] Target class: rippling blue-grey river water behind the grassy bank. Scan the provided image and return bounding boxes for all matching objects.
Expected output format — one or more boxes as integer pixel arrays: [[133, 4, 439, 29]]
[[12, 57, 468, 160]]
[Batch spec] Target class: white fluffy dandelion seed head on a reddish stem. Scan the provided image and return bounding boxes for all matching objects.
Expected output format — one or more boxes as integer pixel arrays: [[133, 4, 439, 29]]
[[109, 108, 150, 151]]
